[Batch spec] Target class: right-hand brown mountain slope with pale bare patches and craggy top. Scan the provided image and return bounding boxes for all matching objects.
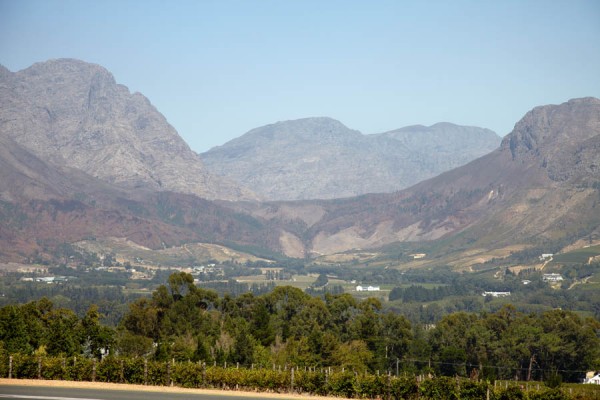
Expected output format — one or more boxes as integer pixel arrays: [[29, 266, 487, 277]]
[[234, 98, 600, 255]]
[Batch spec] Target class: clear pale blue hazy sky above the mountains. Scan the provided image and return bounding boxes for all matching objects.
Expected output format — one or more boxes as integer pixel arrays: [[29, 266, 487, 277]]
[[0, 0, 600, 152]]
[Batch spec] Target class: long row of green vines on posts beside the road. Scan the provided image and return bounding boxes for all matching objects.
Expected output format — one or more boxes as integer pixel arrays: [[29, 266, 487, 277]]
[[0, 354, 600, 400]]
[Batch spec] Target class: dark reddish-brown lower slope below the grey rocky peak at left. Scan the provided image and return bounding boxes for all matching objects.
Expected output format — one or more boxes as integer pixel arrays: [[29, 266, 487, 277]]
[[0, 136, 278, 262]]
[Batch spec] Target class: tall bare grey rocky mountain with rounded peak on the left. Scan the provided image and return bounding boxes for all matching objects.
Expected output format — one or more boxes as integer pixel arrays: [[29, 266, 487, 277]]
[[0, 59, 255, 200]]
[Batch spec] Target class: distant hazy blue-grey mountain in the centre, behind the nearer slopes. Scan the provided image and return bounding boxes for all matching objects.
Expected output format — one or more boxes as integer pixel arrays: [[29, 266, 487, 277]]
[[201, 118, 500, 200]]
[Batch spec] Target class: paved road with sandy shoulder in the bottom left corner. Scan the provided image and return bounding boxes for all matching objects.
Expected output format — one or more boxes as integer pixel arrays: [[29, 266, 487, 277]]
[[0, 384, 292, 400]]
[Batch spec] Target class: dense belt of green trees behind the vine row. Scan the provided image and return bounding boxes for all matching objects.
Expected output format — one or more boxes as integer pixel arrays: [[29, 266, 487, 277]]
[[0, 273, 600, 381]]
